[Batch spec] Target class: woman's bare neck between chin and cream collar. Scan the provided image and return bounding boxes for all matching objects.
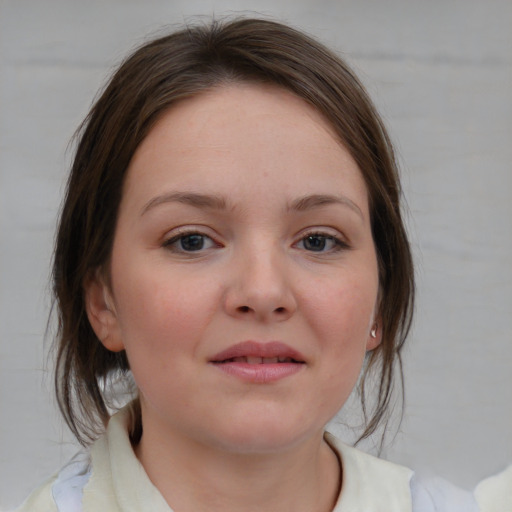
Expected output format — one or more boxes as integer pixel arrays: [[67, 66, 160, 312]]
[[135, 416, 341, 512]]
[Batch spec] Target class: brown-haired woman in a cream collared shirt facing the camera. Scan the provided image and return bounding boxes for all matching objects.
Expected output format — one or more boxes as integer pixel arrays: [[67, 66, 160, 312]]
[[16, 19, 480, 512]]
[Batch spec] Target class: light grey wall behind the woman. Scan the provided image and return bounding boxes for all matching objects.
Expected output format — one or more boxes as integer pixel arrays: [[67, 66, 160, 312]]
[[0, 0, 512, 509]]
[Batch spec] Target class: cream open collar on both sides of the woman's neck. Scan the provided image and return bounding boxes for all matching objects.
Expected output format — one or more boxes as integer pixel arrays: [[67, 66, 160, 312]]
[[83, 408, 412, 512]]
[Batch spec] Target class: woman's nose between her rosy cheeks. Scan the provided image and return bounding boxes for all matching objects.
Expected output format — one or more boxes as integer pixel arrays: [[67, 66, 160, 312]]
[[225, 242, 297, 322]]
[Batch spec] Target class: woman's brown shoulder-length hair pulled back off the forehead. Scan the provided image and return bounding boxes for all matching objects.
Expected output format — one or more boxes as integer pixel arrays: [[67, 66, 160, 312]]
[[53, 19, 414, 443]]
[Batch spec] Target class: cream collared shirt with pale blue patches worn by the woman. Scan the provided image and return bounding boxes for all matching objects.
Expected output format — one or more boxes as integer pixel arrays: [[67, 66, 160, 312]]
[[17, 410, 480, 512]]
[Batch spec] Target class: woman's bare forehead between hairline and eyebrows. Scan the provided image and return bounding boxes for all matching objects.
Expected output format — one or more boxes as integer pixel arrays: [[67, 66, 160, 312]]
[[121, 84, 366, 214]]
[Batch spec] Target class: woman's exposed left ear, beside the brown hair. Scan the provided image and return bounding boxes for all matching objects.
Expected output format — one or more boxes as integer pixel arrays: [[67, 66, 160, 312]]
[[84, 269, 124, 352]]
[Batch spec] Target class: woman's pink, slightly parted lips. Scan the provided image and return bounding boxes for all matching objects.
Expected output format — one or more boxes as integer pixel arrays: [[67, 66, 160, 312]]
[[210, 341, 305, 383]]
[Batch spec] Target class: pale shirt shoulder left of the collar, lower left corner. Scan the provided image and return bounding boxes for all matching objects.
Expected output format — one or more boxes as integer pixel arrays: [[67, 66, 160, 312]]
[[15, 452, 91, 512]]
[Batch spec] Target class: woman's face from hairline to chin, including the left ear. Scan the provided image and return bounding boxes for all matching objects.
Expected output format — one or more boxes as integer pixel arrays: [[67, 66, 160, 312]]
[[87, 85, 379, 452]]
